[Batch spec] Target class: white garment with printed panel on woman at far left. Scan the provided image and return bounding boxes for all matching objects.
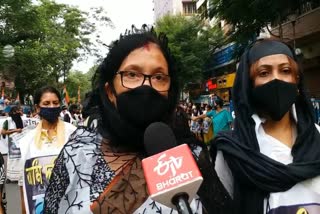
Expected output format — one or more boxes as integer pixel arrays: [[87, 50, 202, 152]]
[[19, 122, 76, 213]]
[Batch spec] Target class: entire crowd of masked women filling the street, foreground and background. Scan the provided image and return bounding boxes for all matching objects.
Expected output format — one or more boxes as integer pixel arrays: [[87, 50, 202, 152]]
[[0, 25, 320, 214]]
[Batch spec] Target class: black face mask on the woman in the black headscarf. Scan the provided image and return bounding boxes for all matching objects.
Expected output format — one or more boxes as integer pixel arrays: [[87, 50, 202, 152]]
[[252, 79, 298, 121]]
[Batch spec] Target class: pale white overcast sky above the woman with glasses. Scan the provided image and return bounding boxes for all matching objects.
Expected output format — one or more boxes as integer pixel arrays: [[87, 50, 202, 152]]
[[56, 0, 154, 72]]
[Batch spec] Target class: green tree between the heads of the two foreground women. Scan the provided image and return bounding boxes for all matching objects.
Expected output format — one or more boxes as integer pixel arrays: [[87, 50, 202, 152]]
[[155, 15, 223, 89]]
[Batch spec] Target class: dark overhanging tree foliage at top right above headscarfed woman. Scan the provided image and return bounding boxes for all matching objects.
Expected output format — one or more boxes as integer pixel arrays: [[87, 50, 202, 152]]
[[209, 0, 317, 49]]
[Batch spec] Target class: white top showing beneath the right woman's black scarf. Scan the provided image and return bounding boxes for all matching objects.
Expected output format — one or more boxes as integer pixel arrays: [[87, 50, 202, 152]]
[[215, 109, 320, 214]]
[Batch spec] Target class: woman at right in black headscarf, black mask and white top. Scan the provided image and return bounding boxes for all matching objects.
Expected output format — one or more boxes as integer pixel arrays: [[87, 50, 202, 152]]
[[210, 40, 320, 214]]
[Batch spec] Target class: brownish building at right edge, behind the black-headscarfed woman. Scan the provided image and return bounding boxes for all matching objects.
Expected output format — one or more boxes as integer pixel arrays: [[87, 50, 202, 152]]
[[272, 3, 320, 99]]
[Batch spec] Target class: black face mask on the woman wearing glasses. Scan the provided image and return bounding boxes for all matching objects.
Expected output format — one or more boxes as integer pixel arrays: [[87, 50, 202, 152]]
[[117, 85, 169, 129]]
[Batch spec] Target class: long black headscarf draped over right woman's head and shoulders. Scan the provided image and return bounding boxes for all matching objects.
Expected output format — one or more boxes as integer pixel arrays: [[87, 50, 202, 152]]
[[210, 40, 320, 214]]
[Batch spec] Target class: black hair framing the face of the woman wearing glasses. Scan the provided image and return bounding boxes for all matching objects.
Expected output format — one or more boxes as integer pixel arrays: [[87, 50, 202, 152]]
[[83, 28, 179, 128]]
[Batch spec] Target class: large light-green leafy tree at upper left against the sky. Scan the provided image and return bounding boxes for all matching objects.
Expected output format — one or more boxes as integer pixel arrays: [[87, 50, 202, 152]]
[[0, 0, 111, 102]]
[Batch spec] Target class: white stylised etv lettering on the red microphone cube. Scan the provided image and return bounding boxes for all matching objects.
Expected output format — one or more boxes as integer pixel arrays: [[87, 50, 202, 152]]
[[153, 153, 182, 176]]
